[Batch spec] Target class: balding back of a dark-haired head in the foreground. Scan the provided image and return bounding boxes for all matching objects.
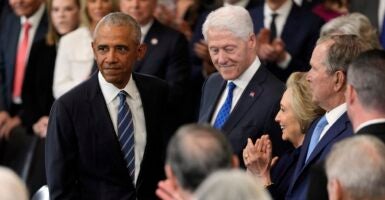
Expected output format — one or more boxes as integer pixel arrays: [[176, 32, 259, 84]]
[[166, 124, 232, 192]]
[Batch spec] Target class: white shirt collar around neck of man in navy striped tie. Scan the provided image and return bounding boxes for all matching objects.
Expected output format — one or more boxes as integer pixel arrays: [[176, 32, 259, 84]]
[[98, 72, 136, 104]]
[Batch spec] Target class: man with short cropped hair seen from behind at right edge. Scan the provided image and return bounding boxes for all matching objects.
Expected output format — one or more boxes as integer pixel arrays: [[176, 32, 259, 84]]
[[346, 50, 385, 142]]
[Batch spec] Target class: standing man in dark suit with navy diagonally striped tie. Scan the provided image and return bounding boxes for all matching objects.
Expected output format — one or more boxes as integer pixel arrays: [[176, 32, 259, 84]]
[[46, 13, 168, 200]]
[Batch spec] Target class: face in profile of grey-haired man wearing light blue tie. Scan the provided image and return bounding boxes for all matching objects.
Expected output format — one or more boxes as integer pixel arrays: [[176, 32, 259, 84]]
[[306, 41, 334, 111]]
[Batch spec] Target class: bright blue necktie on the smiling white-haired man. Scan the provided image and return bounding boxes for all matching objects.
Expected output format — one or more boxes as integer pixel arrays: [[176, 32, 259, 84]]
[[214, 82, 236, 129]]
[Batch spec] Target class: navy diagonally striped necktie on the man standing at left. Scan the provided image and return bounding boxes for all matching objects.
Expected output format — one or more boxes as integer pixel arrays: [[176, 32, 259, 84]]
[[118, 90, 135, 182]]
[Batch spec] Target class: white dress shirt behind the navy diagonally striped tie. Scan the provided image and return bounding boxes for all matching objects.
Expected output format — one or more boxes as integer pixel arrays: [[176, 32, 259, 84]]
[[98, 72, 147, 184]]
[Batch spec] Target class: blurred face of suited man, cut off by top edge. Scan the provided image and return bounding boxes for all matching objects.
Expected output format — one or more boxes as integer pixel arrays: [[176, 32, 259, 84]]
[[120, 0, 156, 26]]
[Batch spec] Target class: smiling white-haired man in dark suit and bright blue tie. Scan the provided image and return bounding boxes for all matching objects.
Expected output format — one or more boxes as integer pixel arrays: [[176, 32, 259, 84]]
[[199, 6, 290, 167]]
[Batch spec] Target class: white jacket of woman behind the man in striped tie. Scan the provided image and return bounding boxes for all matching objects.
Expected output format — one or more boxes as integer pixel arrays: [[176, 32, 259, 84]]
[[53, 27, 94, 99]]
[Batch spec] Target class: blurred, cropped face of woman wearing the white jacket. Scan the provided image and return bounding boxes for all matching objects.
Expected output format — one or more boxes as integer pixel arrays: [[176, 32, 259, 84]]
[[87, 0, 113, 24]]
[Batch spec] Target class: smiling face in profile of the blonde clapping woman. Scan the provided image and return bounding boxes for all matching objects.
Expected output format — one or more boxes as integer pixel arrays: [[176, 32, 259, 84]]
[[275, 88, 304, 146]]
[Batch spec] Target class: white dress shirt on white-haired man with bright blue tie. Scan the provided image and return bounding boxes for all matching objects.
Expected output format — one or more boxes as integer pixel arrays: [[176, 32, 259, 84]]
[[211, 57, 261, 125]]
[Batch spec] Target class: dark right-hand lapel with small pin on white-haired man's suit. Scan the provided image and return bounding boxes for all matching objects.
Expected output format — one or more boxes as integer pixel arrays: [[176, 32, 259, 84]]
[[223, 65, 267, 132]]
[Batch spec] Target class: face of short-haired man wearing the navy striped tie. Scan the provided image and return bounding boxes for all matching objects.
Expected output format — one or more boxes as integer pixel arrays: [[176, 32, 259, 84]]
[[92, 25, 145, 89]]
